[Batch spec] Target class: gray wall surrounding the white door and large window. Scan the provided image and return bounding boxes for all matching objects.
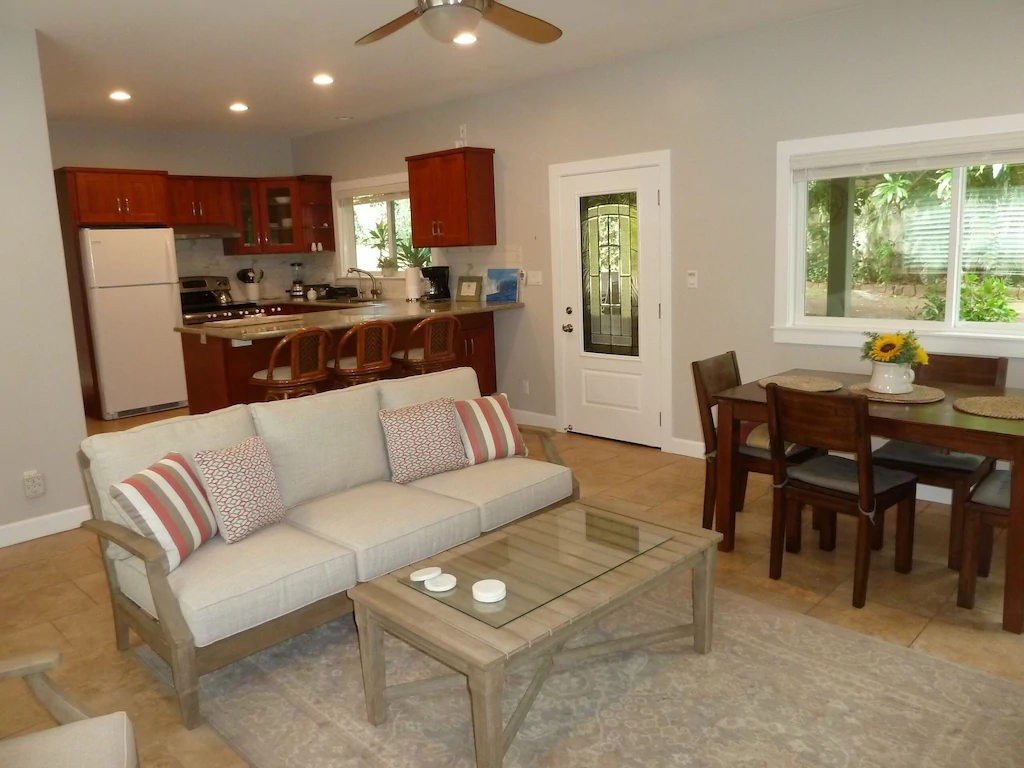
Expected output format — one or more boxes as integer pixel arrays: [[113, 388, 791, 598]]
[[293, 0, 1024, 439]]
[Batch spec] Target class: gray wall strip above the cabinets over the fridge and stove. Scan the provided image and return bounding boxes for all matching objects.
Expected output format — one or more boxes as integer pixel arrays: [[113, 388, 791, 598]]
[[49, 121, 292, 176]]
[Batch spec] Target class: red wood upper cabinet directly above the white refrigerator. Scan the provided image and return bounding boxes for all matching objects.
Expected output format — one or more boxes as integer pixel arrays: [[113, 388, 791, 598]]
[[67, 168, 168, 225]]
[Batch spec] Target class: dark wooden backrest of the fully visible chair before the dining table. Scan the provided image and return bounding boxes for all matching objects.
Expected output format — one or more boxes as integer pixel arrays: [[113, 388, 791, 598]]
[[766, 383, 874, 510]]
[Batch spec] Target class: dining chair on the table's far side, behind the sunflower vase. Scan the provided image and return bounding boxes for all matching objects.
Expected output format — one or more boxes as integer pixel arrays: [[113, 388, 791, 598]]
[[874, 354, 1007, 570]]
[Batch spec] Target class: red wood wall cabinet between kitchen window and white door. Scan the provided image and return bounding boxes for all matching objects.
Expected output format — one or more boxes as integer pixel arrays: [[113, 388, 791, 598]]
[[406, 146, 498, 248]]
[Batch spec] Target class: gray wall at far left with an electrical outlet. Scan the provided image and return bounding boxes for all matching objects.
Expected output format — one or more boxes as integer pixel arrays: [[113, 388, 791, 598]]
[[0, 25, 85, 528]]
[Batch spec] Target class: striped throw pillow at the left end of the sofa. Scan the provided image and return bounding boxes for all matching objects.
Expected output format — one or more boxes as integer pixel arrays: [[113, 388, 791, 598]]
[[111, 454, 217, 570]]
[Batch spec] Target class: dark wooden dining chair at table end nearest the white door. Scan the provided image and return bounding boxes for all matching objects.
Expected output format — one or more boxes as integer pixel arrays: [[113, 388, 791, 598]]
[[690, 351, 821, 530]]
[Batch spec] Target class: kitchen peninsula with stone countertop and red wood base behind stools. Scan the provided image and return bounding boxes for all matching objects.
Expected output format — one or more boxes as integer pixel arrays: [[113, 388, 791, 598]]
[[174, 301, 524, 414]]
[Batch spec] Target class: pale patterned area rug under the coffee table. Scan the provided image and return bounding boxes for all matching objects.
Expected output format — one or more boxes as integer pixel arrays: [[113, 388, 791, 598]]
[[140, 580, 1024, 768]]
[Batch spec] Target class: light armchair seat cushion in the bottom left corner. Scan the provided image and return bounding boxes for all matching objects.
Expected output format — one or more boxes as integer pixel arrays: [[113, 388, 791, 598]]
[[0, 712, 138, 768]]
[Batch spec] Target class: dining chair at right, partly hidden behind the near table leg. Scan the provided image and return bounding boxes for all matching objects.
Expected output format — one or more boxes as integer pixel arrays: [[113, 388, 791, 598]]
[[956, 469, 1011, 608]]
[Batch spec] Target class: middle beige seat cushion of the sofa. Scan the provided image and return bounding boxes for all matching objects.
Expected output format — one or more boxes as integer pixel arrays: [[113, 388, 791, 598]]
[[288, 482, 480, 582]]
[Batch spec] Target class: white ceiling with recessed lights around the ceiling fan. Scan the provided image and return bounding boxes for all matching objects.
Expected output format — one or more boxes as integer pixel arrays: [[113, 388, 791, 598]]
[[0, 0, 863, 135]]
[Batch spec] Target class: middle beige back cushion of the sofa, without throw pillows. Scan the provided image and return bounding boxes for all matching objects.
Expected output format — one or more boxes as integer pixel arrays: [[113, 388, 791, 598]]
[[250, 383, 391, 507]]
